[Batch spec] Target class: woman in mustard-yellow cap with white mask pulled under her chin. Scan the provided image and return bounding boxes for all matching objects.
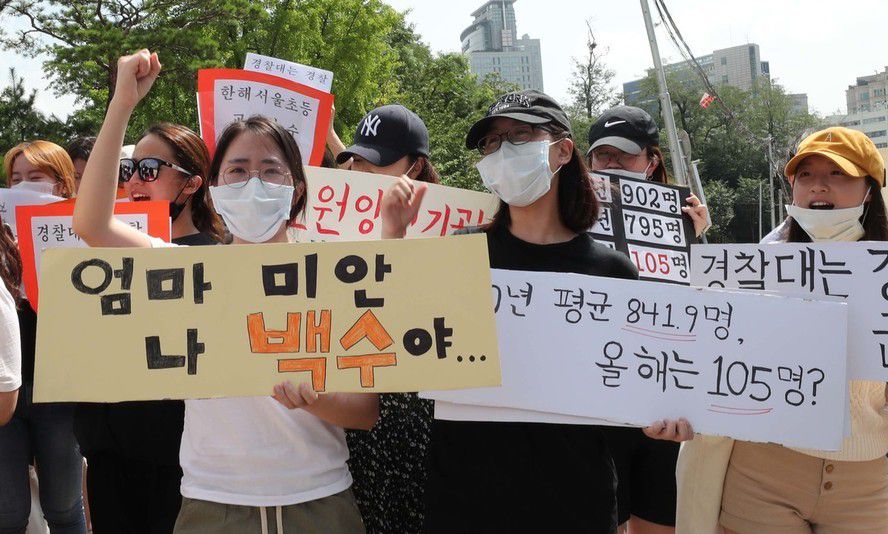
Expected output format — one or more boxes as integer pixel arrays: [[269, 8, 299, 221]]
[[678, 127, 888, 534]]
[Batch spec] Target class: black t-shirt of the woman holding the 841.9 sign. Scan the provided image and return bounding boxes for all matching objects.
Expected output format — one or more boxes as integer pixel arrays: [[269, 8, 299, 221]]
[[425, 228, 638, 534]]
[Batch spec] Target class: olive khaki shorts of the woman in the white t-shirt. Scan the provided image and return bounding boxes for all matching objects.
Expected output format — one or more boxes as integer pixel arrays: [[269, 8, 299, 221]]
[[174, 489, 364, 534]]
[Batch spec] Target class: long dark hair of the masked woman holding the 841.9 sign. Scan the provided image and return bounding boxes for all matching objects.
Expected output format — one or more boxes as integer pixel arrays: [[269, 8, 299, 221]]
[[488, 123, 600, 233]]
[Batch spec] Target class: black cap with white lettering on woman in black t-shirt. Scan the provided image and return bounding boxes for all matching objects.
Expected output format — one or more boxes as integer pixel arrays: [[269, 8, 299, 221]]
[[466, 89, 570, 148]]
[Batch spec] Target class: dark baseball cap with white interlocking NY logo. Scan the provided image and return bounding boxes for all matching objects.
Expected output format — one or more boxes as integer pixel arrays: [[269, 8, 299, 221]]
[[336, 104, 429, 167]]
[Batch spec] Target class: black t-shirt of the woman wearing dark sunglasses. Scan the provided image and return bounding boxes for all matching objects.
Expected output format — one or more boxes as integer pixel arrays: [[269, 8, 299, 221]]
[[74, 233, 217, 465]]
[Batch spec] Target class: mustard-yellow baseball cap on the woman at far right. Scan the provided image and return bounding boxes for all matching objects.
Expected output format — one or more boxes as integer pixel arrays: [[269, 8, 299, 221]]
[[783, 126, 885, 187]]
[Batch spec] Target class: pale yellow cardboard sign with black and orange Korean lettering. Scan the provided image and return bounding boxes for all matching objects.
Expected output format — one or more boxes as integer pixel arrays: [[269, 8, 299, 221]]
[[34, 235, 500, 402]]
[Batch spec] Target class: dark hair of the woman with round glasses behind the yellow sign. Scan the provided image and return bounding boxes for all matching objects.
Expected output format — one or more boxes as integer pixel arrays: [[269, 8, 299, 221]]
[[209, 115, 305, 225]]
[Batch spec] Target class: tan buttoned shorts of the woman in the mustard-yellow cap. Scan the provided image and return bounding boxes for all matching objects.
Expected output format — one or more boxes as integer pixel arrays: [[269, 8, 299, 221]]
[[719, 441, 888, 534]]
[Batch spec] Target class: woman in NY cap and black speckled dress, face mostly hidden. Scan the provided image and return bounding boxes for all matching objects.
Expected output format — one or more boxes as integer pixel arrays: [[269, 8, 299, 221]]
[[336, 104, 438, 533]]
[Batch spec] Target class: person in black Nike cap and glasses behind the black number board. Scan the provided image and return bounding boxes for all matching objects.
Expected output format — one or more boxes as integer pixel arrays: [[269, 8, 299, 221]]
[[586, 106, 708, 236]]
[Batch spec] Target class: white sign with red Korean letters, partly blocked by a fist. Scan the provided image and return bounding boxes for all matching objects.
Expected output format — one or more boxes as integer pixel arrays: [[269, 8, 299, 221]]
[[290, 167, 499, 242]]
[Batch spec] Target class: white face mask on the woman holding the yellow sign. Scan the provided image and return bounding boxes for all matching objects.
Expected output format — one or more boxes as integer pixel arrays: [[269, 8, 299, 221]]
[[210, 176, 295, 243]]
